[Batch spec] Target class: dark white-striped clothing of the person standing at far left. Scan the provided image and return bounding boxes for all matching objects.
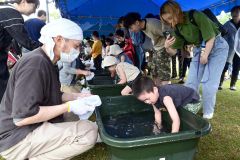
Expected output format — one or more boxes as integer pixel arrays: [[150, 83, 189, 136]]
[[0, 6, 40, 101]]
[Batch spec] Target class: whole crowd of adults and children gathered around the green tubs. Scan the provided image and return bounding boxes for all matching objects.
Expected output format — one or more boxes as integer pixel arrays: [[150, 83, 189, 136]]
[[0, 0, 240, 160]]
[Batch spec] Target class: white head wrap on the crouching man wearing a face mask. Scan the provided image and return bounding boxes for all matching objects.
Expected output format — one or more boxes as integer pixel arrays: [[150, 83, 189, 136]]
[[39, 18, 83, 44]]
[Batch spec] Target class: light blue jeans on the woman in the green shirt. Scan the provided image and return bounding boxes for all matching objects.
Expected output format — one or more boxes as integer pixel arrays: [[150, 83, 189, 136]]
[[185, 36, 229, 114]]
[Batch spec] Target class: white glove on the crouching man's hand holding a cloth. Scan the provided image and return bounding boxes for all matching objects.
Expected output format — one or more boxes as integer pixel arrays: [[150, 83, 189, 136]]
[[68, 99, 95, 116]]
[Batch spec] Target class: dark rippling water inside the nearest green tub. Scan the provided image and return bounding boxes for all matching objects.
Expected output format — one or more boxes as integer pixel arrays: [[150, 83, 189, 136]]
[[103, 112, 170, 138]]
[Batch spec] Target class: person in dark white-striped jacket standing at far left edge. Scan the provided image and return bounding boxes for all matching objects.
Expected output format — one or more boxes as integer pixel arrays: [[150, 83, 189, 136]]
[[0, 0, 40, 101]]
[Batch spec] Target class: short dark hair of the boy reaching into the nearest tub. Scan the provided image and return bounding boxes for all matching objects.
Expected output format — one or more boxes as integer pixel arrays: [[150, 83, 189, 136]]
[[132, 76, 156, 97]]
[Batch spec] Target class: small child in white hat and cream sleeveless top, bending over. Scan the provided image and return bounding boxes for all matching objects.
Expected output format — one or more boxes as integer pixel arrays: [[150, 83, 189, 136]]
[[103, 56, 141, 95]]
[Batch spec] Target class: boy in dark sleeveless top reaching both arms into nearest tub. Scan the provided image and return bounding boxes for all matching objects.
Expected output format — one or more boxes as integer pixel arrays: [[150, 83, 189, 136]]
[[132, 77, 201, 133]]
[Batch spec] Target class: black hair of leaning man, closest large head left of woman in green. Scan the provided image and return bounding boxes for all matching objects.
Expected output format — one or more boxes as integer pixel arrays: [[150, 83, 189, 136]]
[[124, 12, 141, 28]]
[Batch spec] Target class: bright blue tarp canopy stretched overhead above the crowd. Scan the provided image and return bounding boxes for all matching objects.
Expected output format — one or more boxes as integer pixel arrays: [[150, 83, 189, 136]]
[[56, 0, 240, 33]]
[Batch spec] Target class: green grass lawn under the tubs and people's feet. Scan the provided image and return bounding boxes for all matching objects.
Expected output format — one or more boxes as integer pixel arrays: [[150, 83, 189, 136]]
[[0, 81, 240, 160]]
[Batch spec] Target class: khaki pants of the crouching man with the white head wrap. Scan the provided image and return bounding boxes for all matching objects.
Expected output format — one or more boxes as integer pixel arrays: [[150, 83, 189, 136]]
[[1, 121, 98, 160]]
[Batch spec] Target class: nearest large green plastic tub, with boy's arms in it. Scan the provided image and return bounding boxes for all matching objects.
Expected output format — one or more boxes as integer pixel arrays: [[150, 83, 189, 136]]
[[96, 96, 211, 160]]
